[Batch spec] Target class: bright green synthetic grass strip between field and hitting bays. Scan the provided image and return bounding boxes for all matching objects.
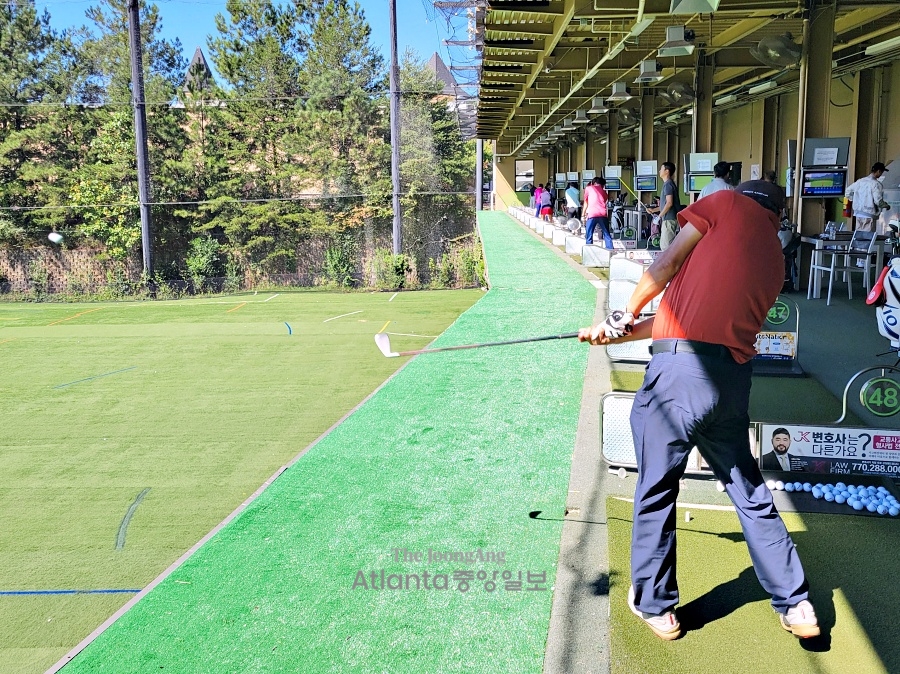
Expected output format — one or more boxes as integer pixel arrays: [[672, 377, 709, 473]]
[[64, 213, 595, 674]]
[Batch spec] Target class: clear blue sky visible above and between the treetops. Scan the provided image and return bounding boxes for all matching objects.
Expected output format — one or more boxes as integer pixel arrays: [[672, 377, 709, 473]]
[[42, 0, 474, 79]]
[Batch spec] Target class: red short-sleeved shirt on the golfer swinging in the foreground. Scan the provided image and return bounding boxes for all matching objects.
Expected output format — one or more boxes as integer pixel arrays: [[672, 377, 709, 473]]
[[653, 190, 784, 363]]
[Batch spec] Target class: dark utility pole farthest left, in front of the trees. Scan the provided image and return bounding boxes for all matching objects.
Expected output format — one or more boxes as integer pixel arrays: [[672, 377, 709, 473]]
[[128, 0, 153, 276]]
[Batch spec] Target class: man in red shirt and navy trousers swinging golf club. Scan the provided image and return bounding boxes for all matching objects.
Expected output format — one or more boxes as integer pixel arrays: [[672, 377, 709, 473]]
[[579, 180, 819, 639]]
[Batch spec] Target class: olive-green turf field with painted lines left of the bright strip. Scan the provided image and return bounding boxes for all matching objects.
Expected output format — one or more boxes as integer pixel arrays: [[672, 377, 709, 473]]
[[0, 290, 482, 673]]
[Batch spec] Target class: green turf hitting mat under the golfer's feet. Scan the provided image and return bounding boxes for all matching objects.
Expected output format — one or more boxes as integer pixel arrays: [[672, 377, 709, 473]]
[[607, 499, 900, 674]]
